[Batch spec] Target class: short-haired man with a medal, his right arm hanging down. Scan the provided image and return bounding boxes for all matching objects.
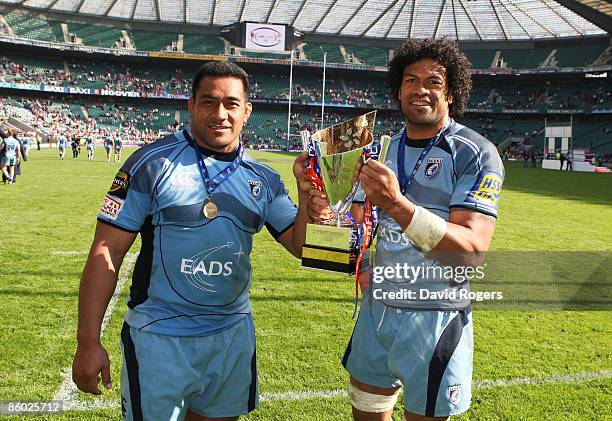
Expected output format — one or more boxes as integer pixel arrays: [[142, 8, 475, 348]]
[[73, 62, 316, 421]]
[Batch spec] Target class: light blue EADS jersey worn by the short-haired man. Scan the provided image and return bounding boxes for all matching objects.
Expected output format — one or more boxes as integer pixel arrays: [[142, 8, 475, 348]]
[[98, 131, 297, 336]]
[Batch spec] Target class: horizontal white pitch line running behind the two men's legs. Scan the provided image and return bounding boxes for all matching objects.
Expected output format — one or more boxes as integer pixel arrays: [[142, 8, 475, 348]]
[[59, 370, 612, 411]]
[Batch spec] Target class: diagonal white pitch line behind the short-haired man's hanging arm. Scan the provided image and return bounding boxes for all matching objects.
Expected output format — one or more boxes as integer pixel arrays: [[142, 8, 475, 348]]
[[53, 253, 137, 410]]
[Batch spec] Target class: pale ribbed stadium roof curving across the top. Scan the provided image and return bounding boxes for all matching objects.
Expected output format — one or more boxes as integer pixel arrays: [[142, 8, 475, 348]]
[[0, 0, 612, 41]]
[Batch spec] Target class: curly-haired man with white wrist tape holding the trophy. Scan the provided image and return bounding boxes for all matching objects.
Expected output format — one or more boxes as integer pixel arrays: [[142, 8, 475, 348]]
[[311, 39, 504, 421]]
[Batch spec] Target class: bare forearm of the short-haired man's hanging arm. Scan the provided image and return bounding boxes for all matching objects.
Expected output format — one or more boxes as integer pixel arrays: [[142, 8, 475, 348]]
[[77, 247, 122, 346]]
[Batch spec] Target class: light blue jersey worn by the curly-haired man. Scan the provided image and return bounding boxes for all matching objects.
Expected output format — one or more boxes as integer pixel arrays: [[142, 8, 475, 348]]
[[358, 122, 504, 310]]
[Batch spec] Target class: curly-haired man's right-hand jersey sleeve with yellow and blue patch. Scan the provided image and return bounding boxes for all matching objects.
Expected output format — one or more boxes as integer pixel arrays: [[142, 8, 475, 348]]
[[450, 140, 504, 217]]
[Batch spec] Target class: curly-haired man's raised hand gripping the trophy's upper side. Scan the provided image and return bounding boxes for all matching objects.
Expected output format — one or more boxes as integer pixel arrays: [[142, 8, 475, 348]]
[[359, 159, 403, 210]]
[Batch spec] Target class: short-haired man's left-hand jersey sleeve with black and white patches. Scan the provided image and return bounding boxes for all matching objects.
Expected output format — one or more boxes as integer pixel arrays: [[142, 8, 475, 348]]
[[98, 155, 151, 232]]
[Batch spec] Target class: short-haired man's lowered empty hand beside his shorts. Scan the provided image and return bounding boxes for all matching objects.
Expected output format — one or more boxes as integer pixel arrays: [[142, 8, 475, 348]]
[[72, 342, 112, 395]]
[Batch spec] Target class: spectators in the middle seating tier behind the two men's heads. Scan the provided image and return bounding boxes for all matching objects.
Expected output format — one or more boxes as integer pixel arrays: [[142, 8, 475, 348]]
[[0, 56, 612, 109]]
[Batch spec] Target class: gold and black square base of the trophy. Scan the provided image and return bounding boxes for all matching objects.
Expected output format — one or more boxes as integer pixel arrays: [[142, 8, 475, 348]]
[[302, 224, 357, 275]]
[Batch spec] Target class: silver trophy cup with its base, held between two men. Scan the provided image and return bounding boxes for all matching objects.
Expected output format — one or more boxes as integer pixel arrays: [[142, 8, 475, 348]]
[[302, 111, 391, 273]]
